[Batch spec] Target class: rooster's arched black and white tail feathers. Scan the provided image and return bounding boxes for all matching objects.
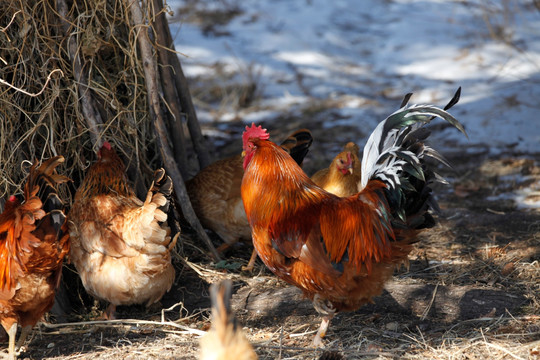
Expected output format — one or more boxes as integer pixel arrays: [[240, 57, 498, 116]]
[[361, 89, 467, 229]]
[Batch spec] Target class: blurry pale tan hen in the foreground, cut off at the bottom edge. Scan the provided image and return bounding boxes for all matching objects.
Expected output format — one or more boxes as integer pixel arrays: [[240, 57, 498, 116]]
[[200, 280, 257, 360]]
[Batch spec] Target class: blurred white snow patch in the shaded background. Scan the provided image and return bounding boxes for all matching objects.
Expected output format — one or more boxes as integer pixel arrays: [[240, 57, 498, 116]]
[[168, 0, 540, 205]]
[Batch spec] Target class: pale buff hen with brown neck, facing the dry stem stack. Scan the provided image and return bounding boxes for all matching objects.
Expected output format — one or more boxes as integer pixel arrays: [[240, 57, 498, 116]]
[[68, 142, 179, 318]]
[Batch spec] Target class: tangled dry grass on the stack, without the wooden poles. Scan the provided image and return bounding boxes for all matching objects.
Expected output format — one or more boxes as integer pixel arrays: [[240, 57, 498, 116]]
[[0, 0, 159, 202]]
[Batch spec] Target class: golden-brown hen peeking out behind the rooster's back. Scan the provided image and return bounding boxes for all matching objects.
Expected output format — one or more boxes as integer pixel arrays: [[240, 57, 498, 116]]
[[311, 142, 361, 197]]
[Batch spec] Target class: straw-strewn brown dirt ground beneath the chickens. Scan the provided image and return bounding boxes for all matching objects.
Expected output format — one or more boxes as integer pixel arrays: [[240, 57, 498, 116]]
[[6, 109, 540, 360]]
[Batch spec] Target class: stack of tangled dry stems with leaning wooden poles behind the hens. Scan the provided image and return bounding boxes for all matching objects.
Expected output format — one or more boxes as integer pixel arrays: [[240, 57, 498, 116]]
[[0, 0, 219, 258]]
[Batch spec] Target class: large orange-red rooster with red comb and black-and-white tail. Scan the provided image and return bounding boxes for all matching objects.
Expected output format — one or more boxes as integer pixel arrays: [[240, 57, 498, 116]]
[[242, 91, 465, 346]]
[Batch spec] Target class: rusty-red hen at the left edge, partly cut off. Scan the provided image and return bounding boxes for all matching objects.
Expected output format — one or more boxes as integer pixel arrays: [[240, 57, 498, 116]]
[[0, 156, 69, 359]]
